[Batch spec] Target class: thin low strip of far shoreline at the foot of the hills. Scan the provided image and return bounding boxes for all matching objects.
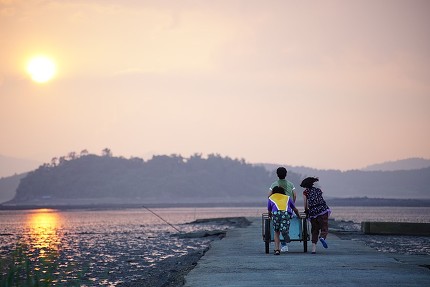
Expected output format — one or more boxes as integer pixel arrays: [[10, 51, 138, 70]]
[[0, 197, 430, 210]]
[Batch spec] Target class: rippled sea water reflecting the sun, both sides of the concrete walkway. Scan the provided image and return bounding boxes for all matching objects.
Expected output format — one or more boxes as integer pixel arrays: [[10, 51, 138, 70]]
[[0, 207, 430, 286]]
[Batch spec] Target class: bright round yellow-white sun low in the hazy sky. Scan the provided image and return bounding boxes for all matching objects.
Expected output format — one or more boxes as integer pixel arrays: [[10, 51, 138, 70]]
[[27, 56, 57, 83]]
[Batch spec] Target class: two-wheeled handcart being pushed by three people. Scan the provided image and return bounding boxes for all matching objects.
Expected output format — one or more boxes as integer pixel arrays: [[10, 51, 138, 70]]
[[261, 213, 310, 253]]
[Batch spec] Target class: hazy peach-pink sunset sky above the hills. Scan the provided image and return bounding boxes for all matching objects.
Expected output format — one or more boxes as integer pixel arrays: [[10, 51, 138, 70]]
[[0, 0, 430, 170]]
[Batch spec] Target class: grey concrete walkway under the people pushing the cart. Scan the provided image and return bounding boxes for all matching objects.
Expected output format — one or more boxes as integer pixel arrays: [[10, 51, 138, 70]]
[[185, 218, 430, 287]]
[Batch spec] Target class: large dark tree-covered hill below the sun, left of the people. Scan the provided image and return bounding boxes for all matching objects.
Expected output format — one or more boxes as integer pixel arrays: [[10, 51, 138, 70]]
[[9, 155, 300, 204]]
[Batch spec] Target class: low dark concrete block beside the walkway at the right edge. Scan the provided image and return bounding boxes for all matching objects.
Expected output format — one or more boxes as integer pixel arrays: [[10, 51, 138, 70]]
[[361, 221, 430, 236]]
